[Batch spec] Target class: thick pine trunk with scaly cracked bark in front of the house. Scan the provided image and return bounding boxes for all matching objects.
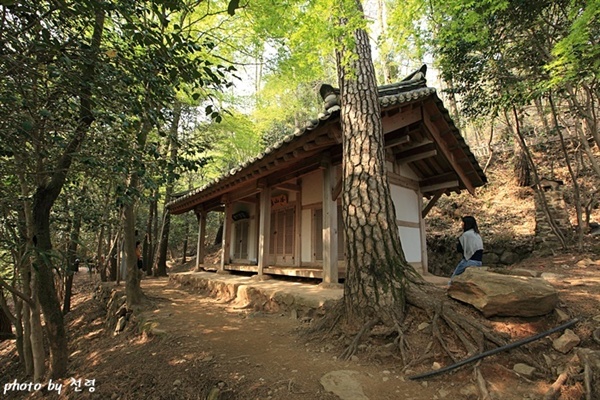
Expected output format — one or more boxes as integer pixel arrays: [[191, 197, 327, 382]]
[[336, 1, 415, 326]]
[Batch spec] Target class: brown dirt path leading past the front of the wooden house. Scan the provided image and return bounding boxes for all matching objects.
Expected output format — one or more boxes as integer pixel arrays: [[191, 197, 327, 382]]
[[129, 279, 442, 400]]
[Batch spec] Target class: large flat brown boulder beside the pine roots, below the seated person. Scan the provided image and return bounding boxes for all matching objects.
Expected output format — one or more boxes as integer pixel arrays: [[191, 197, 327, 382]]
[[448, 267, 558, 318]]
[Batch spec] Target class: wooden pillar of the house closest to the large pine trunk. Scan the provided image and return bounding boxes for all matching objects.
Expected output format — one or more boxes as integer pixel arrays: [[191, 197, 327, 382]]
[[323, 162, 339, 284]]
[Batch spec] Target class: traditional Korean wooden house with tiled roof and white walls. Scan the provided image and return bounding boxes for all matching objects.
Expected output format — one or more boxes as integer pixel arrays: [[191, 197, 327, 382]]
[[168, 69, 486, 283]]
